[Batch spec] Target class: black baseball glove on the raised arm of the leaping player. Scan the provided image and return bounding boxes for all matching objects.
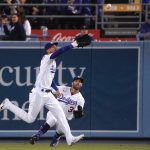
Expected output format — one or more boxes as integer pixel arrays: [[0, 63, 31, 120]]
[[76, 34, 92, 47]]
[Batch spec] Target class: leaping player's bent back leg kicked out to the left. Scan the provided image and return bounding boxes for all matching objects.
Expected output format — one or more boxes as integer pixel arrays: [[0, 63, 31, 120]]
[[1, 92, 44, 123]]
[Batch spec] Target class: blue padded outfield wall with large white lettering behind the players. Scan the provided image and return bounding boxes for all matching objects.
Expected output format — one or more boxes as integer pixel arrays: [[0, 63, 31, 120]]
[[0, 42, 150, 138]]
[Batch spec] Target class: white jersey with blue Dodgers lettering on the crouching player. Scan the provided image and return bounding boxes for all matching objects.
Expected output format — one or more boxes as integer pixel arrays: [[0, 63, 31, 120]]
[[54, 86, 85, 120]]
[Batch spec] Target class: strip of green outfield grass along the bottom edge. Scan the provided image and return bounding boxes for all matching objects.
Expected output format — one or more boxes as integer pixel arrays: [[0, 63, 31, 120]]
[[0, 143, 150, 150]]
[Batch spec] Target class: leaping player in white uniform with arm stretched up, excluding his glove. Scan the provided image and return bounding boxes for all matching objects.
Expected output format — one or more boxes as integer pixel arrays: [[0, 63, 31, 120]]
[[0, 41, 84, 145]]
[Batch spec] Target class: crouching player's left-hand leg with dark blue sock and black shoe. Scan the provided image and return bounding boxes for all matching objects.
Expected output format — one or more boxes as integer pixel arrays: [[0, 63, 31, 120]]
[[30, 111, 57, 144]]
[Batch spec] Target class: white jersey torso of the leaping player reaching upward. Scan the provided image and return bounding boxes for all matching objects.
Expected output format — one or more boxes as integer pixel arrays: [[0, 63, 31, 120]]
[[35, 54, 56, 89]]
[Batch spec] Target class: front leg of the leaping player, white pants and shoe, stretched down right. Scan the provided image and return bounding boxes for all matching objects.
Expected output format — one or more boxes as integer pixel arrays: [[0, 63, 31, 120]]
[[45, 93, 84, 145]]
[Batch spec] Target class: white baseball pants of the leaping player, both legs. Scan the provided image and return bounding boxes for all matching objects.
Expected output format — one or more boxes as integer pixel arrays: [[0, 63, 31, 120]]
[[7, 88, 73, 145]]
